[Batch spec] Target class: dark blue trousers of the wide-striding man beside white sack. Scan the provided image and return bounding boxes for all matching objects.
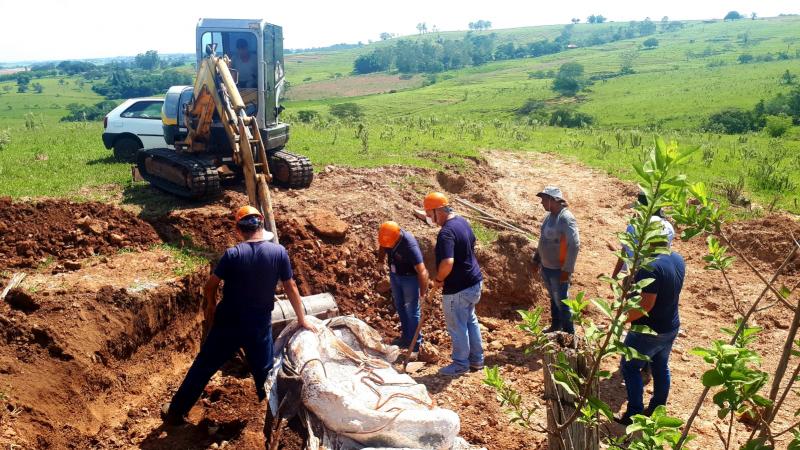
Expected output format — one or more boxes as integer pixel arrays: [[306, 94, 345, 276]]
[[169, 322, 272, 417]]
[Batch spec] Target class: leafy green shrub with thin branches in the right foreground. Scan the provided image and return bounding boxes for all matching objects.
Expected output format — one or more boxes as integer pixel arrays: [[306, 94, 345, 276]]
[[485, 138, 800, 450]]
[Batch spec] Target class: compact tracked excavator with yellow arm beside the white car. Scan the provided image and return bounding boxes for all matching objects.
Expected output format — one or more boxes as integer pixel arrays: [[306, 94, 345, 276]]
[[136, 19, 314, 242]]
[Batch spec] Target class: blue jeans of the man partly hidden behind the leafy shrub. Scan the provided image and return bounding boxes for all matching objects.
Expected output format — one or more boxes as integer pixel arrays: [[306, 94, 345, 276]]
[[619, 330, 678, 416]]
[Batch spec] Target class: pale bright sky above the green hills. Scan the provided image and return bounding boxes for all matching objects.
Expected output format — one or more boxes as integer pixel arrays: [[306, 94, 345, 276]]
[[0, 0, 800, 63]]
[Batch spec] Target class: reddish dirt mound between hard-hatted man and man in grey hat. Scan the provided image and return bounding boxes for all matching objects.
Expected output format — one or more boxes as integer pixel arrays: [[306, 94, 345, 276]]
[[476, 232, 546, 319]]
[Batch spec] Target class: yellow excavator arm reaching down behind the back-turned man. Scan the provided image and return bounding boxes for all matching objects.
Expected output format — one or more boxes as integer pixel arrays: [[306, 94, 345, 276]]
[[180, 48, 278, 242]]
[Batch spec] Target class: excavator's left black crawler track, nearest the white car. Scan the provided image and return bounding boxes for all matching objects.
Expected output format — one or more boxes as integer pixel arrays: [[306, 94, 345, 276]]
[[136, 148, 220, 199]]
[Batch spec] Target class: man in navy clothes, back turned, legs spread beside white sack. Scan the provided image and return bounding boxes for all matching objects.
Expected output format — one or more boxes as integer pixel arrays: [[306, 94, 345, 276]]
[[161, 206, 316, 424]]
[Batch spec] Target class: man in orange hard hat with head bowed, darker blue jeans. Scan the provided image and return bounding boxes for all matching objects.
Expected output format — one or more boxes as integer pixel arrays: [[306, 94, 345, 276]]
[[378, 221, 428, 352]]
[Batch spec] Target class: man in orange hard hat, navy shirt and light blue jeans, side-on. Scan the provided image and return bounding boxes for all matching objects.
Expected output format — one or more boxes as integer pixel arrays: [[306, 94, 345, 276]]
[[423, 192, 483, 376]]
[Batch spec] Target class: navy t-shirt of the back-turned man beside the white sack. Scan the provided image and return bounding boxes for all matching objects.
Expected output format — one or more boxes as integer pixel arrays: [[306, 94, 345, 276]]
[[214, 241, 292, 326]]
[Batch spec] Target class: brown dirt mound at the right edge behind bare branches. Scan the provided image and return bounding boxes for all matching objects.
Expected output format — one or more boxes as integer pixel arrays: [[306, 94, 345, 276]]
[[726, 215, 800, 274]]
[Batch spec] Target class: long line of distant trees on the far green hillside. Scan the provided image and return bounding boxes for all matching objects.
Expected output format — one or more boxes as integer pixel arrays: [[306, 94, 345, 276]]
[[353, 18, 683, 74]]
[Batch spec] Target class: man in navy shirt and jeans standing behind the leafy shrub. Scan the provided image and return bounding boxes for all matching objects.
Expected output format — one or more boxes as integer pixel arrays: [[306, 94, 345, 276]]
[[617, 230, 686, 425]]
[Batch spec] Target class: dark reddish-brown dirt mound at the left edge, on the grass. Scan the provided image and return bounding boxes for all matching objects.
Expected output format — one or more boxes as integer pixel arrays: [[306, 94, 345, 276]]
[[0, 198, 160, 269]]
